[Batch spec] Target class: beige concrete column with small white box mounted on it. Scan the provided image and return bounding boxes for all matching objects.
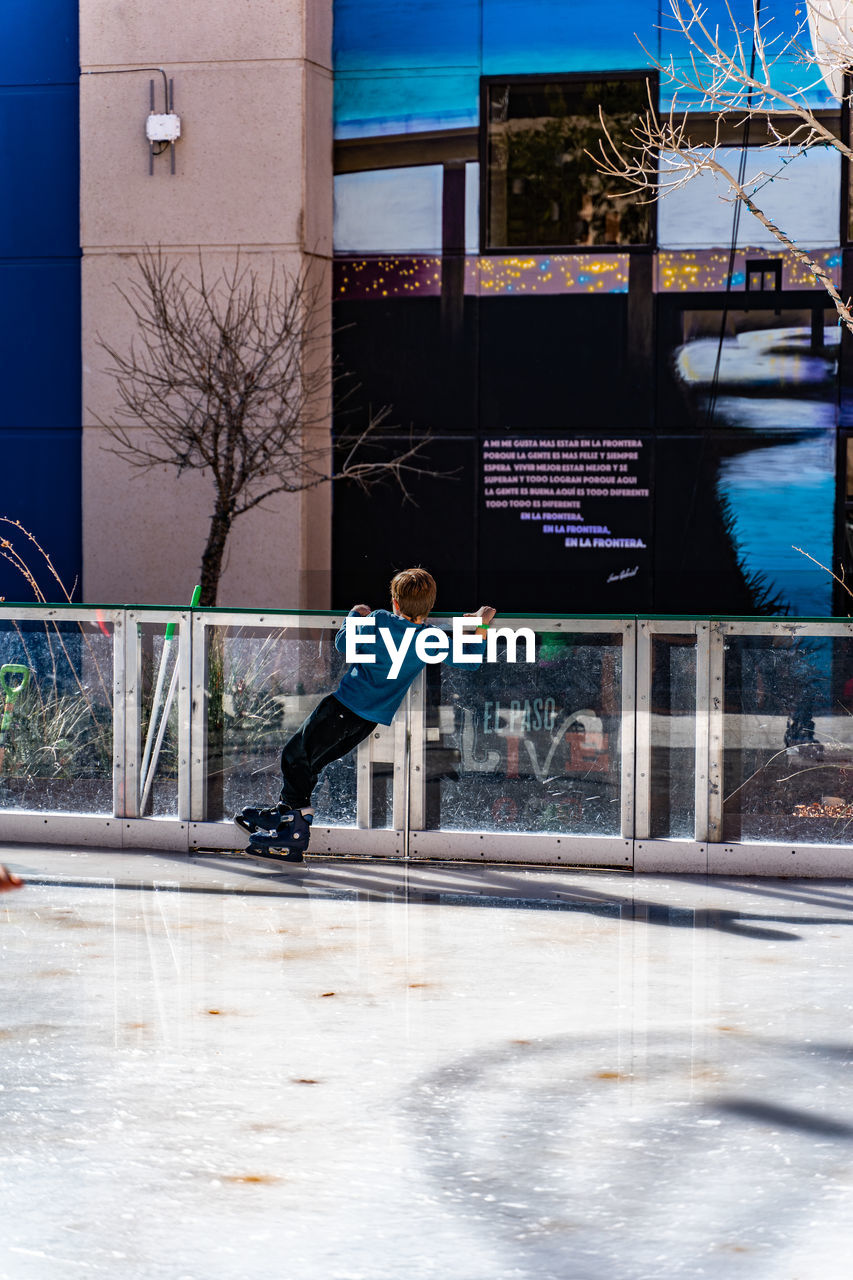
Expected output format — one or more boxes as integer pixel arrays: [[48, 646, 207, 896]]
[[81, 0, 332, 608]]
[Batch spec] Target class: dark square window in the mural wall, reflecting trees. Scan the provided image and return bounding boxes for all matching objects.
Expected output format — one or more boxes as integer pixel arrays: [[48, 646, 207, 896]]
[[487, 76, 653, 248]]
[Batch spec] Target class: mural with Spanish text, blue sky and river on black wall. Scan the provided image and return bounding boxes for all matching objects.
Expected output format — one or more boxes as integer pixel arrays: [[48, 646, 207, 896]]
[[334, 0, 843, 616]]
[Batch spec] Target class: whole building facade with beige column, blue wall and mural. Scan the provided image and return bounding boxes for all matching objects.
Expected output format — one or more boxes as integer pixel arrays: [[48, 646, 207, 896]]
[[0, 0, 853, 616]]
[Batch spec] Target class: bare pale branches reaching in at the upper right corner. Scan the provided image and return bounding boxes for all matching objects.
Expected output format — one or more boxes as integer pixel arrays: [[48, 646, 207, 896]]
[[594, 0, 853, 332]]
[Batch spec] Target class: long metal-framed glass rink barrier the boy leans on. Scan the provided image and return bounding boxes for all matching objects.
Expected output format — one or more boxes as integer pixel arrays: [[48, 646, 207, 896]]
[[0, 604, 853, 876]]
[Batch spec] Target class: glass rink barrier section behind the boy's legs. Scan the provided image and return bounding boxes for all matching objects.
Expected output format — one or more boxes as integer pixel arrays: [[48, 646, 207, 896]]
[[206, 626, 381, 827]]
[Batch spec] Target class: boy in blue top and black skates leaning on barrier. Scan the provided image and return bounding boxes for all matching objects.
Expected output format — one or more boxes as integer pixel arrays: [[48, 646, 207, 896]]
[[234, 568, 494, 863]]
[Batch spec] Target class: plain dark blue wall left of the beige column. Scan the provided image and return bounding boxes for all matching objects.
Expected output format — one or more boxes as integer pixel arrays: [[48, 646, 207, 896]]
[[0, 0, 82, 600]]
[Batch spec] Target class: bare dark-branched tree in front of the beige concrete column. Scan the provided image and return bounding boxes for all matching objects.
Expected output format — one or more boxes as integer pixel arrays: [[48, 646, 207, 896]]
[[97, 250, 424, 605]]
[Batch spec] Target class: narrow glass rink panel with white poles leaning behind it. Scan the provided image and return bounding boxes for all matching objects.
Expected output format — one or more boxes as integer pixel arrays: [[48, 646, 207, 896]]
[[138, 622, 181, 818]]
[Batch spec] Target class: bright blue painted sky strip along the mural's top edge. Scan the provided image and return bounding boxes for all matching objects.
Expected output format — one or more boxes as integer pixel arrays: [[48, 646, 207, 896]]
[[334, 0, 831, 138]]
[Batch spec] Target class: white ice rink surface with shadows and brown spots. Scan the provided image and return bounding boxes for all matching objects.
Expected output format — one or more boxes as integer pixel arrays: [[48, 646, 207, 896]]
[[0, 847, 853, 1280]]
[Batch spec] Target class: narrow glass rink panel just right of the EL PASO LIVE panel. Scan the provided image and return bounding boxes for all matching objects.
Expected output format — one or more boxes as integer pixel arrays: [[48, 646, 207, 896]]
[[649, 635, 697, 840]]
